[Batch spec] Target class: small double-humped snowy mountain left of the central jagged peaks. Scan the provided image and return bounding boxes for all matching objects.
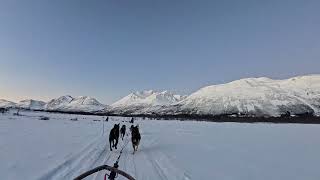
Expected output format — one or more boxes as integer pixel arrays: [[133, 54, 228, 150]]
[[45, 95, 105, 112]]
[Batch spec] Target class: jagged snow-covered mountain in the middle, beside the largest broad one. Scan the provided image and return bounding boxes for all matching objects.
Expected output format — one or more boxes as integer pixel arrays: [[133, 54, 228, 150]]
[[107, 90, 185, 114]]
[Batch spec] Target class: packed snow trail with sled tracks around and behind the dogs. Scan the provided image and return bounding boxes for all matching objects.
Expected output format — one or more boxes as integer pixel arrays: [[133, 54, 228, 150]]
[[38, 121, 190, 180]]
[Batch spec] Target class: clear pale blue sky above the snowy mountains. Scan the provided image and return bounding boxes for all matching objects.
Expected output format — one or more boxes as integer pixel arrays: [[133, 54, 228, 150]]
[[0, 0, 320, 103]]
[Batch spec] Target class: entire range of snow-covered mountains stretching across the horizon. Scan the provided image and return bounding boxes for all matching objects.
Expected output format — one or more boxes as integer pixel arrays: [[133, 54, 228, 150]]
[[0, 75, 320, 116]]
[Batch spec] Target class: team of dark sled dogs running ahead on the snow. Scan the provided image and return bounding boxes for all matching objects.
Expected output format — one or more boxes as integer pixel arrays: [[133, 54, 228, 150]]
[[109, 118, 141, 153]]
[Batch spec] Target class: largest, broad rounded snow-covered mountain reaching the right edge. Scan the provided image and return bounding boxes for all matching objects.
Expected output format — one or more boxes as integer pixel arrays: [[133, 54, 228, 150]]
[[153, 75, 320, 116]]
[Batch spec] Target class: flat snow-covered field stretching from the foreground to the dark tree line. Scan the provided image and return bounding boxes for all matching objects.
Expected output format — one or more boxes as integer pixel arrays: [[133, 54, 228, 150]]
[[0, 112, 320, 180]]
